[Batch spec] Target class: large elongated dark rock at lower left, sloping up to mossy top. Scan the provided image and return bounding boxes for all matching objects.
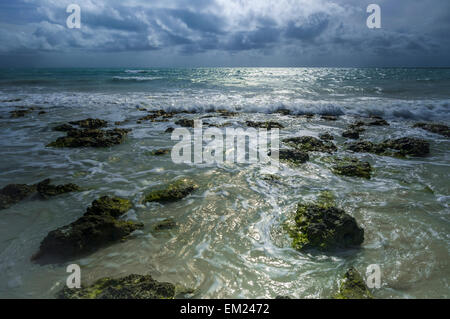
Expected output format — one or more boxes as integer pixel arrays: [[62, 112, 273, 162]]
[[32, 196, 144, 263]]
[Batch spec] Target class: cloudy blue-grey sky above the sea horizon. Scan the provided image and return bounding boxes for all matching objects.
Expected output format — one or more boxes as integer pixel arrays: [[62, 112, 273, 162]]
[[0, 0, 450, 67]]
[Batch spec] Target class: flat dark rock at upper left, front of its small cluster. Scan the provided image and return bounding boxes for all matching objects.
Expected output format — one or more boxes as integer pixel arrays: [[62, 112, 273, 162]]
[[47, 128, 131, 148]]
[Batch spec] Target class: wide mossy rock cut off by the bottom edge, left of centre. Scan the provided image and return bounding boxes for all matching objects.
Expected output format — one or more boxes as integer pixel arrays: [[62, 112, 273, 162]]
[[58, 275, 175, 299]]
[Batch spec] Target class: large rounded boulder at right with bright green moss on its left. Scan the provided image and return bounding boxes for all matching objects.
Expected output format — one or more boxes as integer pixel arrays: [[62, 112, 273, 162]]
[[288, 201, 364, 250]]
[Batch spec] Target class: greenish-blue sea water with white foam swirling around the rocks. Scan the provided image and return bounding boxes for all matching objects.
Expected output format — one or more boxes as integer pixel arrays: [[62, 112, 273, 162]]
[[0, 69, 450, 298]]
